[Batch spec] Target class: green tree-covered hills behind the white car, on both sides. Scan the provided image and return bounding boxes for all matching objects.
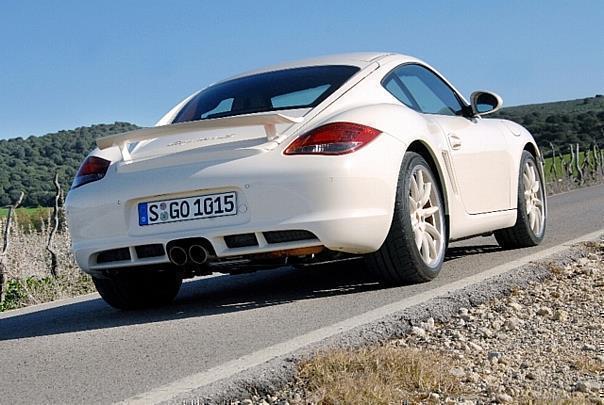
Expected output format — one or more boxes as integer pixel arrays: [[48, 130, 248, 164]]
[[0, 95, 604, 207]]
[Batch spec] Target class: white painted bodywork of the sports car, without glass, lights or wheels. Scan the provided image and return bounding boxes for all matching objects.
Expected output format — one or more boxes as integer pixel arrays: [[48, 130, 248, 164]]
[[66, 53, 539, 272]]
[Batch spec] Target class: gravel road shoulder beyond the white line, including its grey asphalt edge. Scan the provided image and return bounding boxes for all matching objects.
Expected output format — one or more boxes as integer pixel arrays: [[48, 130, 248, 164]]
[[190, 240, 604, 404]]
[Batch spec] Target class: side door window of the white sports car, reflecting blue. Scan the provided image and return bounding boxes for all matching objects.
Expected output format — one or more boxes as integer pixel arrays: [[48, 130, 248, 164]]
[[386, 65, 463, 115]]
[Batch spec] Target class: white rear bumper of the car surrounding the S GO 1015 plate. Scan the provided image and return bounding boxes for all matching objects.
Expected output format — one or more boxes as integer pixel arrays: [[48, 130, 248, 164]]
[[66, 134, 404, 272]]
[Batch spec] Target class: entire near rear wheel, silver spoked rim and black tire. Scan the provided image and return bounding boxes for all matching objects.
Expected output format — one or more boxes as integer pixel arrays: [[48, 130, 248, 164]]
[[367, 152, 447, 285]]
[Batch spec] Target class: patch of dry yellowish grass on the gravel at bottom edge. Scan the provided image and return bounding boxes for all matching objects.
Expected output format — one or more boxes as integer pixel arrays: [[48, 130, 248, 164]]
[[298, 344, 461, 405]]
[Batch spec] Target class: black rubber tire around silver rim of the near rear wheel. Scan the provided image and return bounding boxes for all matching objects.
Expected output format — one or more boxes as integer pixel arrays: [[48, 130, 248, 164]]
[[366, 152, 448, 285]]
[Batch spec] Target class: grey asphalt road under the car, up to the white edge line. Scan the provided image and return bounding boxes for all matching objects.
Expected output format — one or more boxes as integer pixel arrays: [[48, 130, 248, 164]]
[[0, 185, 604, 404]]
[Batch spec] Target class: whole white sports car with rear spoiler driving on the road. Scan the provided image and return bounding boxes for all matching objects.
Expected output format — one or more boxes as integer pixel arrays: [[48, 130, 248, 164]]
[[66, 53, 546, 308]]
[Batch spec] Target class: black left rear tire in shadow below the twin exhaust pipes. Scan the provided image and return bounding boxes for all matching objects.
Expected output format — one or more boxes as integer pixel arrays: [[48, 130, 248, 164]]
[[92, 271, 182, 309]]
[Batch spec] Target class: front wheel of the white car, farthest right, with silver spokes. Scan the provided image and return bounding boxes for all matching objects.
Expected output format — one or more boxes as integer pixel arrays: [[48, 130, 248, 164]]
[[495, 151, 547, 249]]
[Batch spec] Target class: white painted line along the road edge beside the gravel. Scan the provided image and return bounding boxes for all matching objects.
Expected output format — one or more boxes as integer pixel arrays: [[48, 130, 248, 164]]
[[119, 229, 604, 405]]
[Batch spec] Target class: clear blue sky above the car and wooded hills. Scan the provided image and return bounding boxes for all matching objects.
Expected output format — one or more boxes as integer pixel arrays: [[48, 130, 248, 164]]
[[0, 0, 604, 138]]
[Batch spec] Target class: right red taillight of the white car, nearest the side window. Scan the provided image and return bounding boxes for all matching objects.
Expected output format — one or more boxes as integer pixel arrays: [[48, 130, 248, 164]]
[[285, 122, 381, 155]]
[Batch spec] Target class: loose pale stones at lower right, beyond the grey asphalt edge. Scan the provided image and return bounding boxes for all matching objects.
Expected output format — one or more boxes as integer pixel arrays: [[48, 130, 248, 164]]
[[223, 241, 604, 404]]
